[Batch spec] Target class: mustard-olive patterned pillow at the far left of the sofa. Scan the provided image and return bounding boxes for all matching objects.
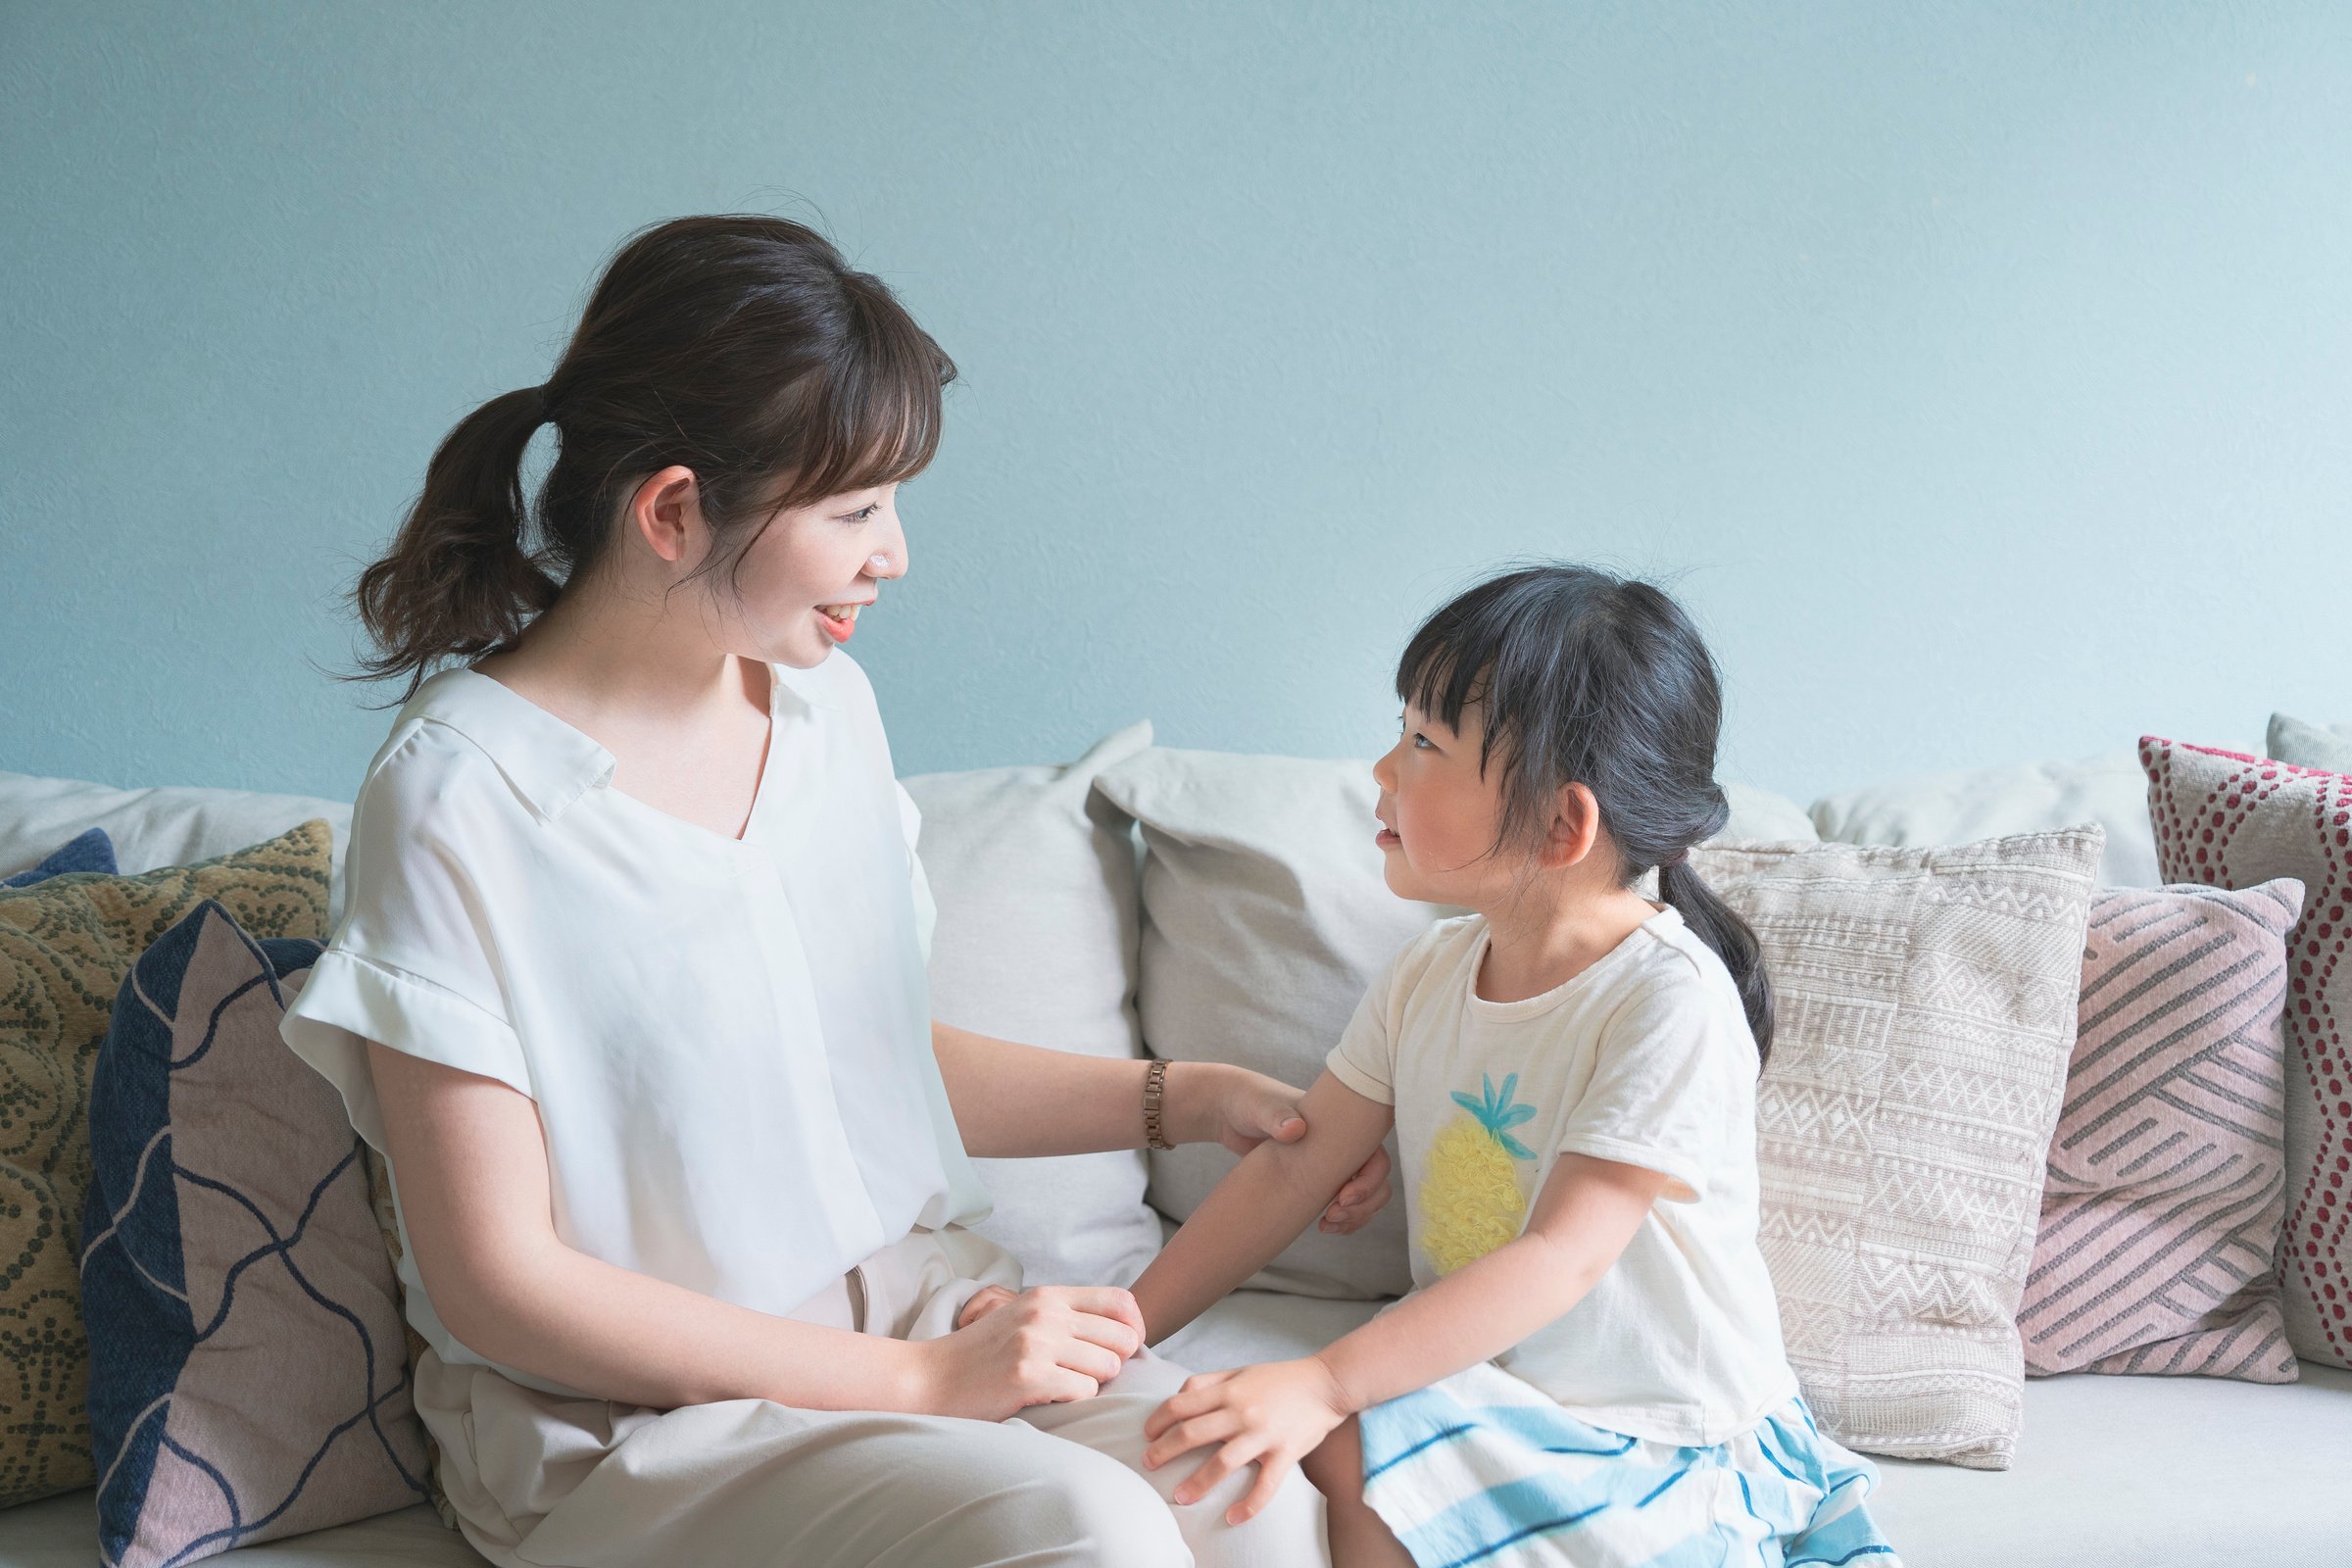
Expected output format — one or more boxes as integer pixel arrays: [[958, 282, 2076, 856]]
[[0, 823, 329, 1507]]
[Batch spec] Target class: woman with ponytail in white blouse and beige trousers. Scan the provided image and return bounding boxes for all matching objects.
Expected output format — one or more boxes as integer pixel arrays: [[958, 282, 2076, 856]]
[[284, 217, 1381, 1568]]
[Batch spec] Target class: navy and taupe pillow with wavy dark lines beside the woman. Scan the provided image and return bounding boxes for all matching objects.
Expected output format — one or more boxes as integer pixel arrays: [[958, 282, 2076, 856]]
[[82, 901, 425, 1568]]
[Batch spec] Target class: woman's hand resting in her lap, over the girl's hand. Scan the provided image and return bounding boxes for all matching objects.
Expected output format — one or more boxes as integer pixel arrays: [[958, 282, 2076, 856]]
[[915, 1286, 1143, 1420]]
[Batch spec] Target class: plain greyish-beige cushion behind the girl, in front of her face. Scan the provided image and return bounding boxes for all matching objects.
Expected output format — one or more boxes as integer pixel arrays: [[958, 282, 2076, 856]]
[[1096, 748, 1811, 1300]]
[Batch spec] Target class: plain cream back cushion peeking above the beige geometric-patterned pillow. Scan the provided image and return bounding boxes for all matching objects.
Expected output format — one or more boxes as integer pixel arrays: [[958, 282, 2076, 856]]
[[1813, 753, 2159, 886]]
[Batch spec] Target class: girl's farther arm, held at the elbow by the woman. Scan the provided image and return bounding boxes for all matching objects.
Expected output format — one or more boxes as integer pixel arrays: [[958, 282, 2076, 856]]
[[1134, 1072, 1390, 1343]]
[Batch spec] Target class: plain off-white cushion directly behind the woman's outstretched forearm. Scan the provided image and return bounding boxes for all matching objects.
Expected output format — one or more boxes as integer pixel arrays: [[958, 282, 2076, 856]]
[[906, 724, 1159, 1284]]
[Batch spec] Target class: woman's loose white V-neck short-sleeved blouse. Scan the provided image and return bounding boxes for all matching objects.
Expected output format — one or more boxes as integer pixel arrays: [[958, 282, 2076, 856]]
[[284, 651, 988, 1394]]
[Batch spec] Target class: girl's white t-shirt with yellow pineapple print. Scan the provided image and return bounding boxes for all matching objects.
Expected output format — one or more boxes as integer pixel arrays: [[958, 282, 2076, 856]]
[[1329, 907, 1797, 1446]]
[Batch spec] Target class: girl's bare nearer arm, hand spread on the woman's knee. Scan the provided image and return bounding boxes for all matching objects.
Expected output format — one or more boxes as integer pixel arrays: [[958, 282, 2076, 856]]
[[1139, 1154, 1668, 1523]]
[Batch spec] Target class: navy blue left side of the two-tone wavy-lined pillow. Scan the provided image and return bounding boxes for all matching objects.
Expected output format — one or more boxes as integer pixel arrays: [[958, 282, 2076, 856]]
[[77, 903, 324, 1561]]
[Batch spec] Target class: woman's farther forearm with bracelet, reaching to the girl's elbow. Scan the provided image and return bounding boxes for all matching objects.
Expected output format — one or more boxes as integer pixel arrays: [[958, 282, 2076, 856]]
[[931, 1022, 1388, 1234]]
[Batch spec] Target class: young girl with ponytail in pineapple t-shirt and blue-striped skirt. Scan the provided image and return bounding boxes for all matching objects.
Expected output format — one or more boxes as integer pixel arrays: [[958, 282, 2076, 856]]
[[1114, 566, 1893, 1568]]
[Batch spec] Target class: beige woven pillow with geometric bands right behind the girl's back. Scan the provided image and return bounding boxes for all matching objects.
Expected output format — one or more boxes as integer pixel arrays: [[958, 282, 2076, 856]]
[[1691, 827, 2100, 1469]]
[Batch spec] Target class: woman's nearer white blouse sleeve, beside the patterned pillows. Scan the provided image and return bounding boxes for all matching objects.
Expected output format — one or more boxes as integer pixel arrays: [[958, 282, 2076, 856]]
[[280, 728, 531, 1150]]
